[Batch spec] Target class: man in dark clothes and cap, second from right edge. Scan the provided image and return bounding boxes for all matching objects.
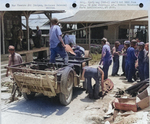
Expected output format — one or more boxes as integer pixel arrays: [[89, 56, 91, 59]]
[[138, 42, 146, 81]]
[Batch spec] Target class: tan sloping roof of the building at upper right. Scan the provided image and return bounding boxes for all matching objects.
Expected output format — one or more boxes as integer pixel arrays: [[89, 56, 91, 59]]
[[59, 10, 148, 23]]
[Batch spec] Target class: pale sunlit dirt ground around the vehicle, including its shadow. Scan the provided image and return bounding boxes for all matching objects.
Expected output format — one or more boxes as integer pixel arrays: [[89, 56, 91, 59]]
[[1, 56, 150, 124]]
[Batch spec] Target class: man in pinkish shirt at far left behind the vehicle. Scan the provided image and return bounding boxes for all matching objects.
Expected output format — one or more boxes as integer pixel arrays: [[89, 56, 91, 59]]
[[6, 45, 22, 77]]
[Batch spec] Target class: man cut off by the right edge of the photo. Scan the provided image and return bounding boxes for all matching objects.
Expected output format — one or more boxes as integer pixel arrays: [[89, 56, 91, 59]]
[[144, 43, 149, 79]]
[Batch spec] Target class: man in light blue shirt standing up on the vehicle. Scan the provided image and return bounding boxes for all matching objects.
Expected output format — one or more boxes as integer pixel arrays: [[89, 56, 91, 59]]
[[50, 18, 68, 64]]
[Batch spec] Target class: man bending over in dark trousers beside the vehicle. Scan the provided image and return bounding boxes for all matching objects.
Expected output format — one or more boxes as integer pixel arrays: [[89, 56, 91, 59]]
[[82, 62, 104, 99]]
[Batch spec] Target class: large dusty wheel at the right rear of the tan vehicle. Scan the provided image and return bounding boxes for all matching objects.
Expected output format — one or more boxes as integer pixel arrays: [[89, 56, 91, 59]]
[[59, 67, 74, 105]]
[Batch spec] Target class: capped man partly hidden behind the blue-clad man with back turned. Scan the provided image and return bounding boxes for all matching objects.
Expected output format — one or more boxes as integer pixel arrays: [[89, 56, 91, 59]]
[[121, 40, 130, 76]]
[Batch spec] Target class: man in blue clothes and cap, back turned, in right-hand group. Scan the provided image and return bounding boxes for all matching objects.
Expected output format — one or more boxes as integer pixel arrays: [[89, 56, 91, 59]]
[[125, 39, 137, 82]]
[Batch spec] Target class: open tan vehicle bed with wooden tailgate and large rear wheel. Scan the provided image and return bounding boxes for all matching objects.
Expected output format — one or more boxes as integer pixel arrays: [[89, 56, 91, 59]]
[[8, 57, 91, 105]]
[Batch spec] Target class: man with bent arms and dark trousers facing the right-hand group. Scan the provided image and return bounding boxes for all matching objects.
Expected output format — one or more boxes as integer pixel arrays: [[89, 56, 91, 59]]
[[112, 41, 121, 76]]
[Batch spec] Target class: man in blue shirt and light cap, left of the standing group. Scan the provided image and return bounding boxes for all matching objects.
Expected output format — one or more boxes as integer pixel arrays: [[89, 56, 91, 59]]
[[100, 38, 112, 80]]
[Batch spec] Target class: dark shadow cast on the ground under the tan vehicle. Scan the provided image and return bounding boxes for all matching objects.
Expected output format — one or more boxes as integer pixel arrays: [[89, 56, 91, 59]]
[[2, 88, 83, 118]]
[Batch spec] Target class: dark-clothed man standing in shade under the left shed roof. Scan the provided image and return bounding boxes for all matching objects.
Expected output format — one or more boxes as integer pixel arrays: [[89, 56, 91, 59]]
[[35, 26, 42, 48]]
